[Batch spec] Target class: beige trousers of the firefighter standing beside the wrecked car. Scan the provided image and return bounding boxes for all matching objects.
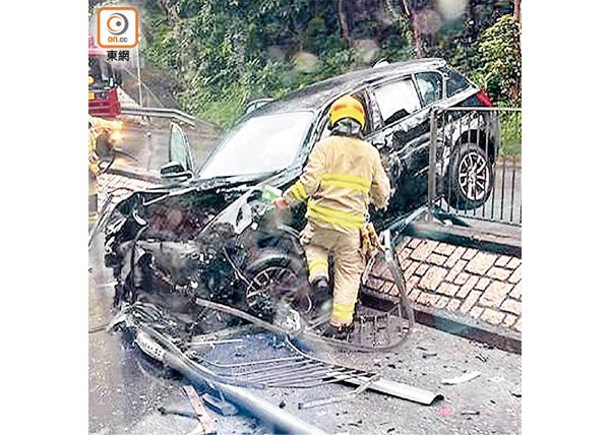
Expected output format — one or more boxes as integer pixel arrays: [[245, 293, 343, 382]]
[[300, 222, 365, 327]]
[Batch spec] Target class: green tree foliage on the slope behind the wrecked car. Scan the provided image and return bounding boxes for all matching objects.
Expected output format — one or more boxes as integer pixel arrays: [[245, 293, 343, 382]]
[[140, 0, 524, 126]]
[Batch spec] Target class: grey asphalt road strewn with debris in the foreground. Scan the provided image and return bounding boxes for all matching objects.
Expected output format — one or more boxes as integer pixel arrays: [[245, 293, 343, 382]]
[[89, 238, 521, 435]]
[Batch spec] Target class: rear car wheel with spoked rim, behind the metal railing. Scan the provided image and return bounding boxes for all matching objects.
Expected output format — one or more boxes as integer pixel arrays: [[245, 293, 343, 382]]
[[446, 143, 494, 210]]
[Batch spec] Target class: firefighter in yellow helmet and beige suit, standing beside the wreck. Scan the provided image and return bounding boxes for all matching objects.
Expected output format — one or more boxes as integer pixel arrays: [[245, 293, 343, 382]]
[[275, 95, 390, 339]]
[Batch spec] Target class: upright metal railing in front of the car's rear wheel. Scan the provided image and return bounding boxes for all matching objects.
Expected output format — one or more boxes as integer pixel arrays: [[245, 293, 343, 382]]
[[428, 107, 522, 226]]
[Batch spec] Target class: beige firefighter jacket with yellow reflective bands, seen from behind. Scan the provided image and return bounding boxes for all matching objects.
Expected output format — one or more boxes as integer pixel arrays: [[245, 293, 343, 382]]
[[283, 136, 390, 233]]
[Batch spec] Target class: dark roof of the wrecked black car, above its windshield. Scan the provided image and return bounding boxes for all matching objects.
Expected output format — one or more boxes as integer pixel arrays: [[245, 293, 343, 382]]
[[244, 58, 447, 119]]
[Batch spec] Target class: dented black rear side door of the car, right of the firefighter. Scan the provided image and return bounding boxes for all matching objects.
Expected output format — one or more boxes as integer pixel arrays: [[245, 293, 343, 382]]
[[369, 74, 442, 215]]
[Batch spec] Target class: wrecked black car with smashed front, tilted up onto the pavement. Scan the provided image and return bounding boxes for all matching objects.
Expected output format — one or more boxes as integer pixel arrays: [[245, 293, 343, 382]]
[[105, 59, 498, 350]]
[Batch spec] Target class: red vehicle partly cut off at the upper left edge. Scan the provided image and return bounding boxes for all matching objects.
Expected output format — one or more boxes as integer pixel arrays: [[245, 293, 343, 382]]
[[89, 36, 121, 118]]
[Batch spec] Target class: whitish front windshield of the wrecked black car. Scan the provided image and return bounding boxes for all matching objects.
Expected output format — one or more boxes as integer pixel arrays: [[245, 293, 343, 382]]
[[199, 112, 313, 178]]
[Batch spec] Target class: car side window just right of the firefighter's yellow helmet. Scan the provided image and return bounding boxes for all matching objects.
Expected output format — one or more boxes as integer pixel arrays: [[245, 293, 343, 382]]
[[372, 79, 421, 124]]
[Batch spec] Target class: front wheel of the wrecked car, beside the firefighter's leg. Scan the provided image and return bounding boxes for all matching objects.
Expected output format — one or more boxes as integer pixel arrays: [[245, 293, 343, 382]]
[[243, 248, 311, 321]]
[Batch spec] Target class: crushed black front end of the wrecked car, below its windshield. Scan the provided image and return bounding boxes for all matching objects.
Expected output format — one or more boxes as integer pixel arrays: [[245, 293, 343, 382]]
[[105, 172, 304, 326]]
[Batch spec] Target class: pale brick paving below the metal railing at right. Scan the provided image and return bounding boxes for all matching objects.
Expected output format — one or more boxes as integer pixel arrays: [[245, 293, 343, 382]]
[[367, 237, 522, 333]]
